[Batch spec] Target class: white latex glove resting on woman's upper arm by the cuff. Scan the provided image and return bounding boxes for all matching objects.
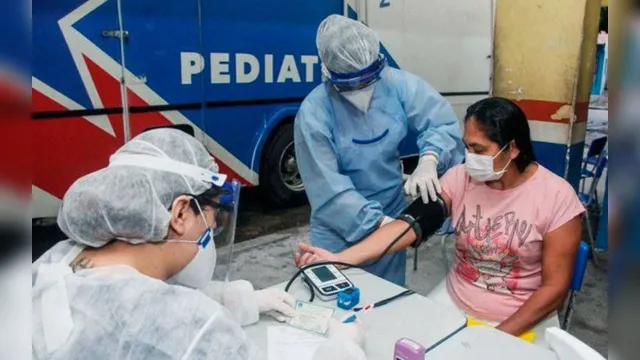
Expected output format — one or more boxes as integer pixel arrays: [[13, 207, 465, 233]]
[[404, 154, 442, 204]]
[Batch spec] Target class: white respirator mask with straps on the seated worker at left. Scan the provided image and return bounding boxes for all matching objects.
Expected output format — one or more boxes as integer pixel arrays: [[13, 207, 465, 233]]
[[167, 200, 217, 289]]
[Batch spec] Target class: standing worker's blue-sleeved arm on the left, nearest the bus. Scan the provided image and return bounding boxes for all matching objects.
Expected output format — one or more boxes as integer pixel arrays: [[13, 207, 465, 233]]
[[294, 101, 383, 243]]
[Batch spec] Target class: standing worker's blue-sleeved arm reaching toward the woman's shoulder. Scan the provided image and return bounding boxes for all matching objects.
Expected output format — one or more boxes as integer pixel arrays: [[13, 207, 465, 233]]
[[394, 70, 464, 174]]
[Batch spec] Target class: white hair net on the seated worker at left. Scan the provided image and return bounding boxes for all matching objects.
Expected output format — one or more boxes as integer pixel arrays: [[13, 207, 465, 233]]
[[58, 128, 218, 247]]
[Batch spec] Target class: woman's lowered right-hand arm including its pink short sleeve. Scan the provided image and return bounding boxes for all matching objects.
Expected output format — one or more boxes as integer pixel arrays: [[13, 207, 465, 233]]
[[497, 183, 584, 336]]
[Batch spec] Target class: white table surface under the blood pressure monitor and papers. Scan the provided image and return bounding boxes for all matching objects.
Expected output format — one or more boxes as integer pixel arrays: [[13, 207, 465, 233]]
[[245, 269, 466, 360]]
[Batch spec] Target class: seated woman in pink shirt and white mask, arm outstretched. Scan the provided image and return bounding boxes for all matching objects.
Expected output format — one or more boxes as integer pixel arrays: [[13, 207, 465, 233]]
[[296, 97, 585, 339]]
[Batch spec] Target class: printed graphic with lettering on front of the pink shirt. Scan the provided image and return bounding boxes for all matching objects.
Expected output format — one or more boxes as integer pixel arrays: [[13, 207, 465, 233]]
[[455, 205, 533, 294]]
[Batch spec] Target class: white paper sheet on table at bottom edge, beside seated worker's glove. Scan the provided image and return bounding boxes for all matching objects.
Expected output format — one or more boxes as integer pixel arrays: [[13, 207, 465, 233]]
[[267, 326, 326, 360]]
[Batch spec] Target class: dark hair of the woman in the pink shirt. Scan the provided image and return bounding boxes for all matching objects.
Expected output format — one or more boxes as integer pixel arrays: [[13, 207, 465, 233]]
[[464, 97, 536, 172]]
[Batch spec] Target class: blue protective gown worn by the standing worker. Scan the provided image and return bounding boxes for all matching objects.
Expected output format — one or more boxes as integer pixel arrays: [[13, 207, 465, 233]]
[[294, 68, 464, 286]]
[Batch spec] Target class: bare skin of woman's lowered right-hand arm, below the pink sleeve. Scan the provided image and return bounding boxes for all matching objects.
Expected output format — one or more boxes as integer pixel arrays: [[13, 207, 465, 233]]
[[497, 216, 582, 336]]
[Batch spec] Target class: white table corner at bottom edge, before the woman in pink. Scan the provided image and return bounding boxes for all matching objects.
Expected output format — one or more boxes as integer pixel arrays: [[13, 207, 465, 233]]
[[425, 326, 558, 360]]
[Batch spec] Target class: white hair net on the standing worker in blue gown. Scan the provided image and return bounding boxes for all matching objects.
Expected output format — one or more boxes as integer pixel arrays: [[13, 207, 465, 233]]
[[316, 15, 380, 74]]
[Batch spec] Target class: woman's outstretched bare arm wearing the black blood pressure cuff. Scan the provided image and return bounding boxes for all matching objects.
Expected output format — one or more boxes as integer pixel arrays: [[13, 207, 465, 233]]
[[295, 191, 451, 266]]
